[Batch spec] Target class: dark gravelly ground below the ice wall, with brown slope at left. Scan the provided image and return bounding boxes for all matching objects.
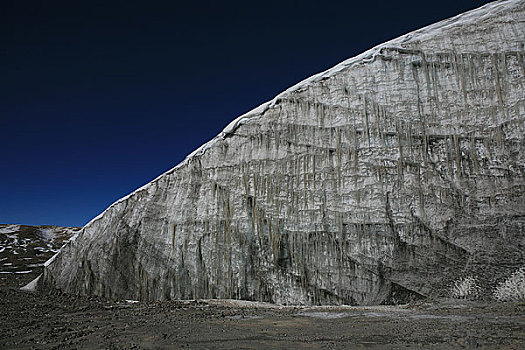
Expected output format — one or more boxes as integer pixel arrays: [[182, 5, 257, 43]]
[[0, 225, 525, 349]]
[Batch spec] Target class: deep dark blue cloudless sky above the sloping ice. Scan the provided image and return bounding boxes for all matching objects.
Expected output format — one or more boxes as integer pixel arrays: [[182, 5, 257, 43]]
[[0, 0, 487, 226]]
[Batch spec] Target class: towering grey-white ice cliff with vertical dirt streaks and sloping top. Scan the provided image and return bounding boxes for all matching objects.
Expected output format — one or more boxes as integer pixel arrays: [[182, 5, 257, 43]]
[[37, 1, 525, 304]]
